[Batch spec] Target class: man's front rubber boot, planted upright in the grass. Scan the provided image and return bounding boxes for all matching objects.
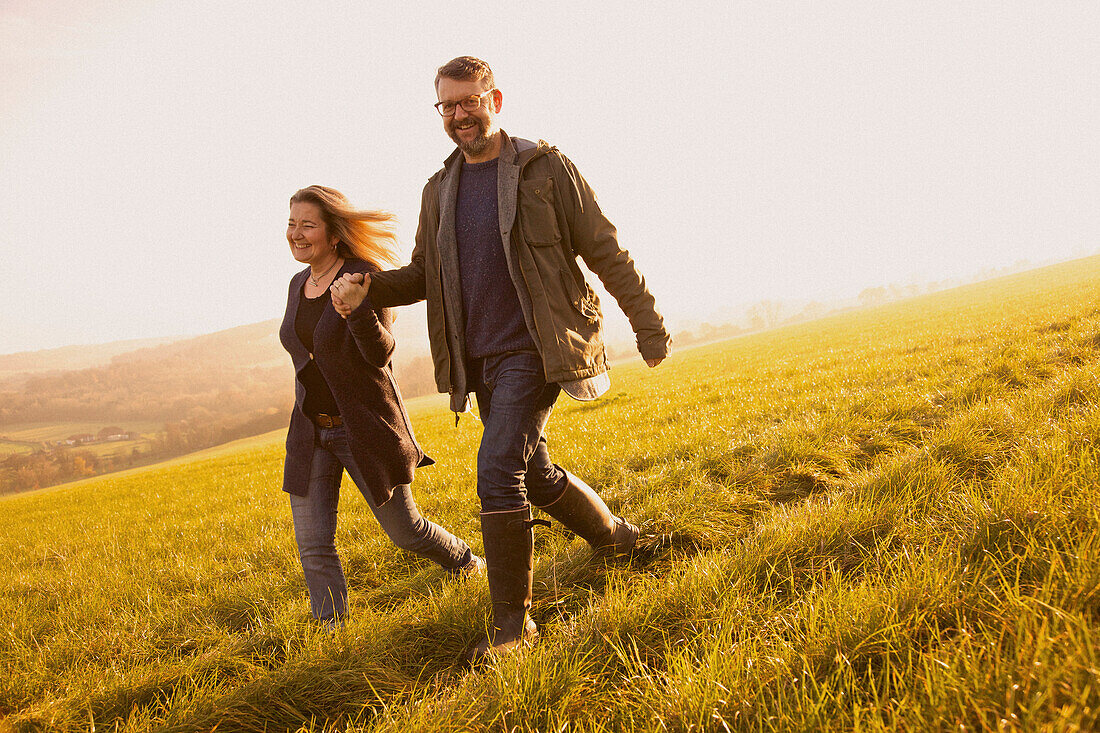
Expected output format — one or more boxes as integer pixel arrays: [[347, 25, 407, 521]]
[[470, 506, 539, 664]]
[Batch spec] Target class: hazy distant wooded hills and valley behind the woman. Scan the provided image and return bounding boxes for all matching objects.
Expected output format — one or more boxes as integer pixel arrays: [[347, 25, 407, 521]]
[[0, 307, 436, 494]]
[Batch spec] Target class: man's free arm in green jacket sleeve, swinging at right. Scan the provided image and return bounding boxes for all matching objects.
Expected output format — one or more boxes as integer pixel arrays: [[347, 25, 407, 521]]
[[550, 151, 672, 367]]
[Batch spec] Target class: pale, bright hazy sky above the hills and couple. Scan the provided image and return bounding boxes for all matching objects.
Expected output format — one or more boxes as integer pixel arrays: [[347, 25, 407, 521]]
[[0, 0, 1100, 353]]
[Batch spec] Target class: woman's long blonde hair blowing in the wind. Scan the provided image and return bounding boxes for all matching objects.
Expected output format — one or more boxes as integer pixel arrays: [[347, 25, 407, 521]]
[[290, 186, 402, 267]]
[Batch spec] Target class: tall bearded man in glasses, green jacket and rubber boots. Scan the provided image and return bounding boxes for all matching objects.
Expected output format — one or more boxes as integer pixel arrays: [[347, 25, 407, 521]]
[[334, 56, 671, 659]]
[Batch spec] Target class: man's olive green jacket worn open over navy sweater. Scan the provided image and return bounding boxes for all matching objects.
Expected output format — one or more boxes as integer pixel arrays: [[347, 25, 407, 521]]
[[370, 131, 672, 412]]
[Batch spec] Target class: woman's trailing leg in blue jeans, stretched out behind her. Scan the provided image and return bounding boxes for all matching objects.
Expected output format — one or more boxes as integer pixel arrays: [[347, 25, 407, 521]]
[[322, 428, 473, 570]]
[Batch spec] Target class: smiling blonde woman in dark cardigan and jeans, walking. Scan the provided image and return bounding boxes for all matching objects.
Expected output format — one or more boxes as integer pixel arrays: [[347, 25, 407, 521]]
[[279, 186, 484, 627]]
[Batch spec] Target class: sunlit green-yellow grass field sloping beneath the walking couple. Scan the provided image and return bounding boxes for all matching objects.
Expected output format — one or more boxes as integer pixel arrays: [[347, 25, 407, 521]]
[[0, 258, 1100, 732]]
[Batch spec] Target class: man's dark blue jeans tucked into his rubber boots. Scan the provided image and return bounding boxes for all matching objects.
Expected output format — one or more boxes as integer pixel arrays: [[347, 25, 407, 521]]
[[470, 351, 565, 512]]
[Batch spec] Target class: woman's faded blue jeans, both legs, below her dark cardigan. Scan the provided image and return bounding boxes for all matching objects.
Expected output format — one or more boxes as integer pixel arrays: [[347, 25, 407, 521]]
[[290, 426, 472, 624]]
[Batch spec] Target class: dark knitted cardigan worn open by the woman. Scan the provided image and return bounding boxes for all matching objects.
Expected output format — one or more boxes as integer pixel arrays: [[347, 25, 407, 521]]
[[279, 259, 433, 504]]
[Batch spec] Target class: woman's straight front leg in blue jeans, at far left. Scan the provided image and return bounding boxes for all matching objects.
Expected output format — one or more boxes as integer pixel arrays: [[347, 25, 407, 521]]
[[290, 446, 348, 626]]
